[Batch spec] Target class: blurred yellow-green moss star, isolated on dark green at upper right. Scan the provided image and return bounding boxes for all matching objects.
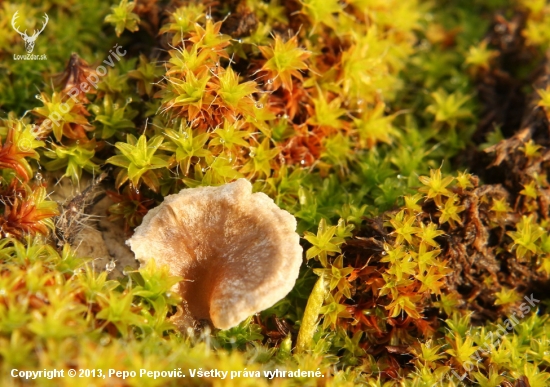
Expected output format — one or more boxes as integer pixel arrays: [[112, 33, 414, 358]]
[[426, 89, 472, 126]]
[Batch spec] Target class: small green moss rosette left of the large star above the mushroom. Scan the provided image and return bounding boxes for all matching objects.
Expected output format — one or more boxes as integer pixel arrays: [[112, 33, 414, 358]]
[[43, 140, 99, 186]]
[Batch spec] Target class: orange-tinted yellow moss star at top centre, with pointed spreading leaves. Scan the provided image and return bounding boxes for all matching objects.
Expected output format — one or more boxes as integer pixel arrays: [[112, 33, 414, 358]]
[[258, 35, 310, 90]]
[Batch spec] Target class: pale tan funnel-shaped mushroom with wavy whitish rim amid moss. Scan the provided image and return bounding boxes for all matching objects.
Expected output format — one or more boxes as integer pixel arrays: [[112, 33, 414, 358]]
[[126, 179, 302, 329]]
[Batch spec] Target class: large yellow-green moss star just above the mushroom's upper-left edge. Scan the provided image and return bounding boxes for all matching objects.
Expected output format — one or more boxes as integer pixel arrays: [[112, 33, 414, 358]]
[[106, 134, 168, 191]]
